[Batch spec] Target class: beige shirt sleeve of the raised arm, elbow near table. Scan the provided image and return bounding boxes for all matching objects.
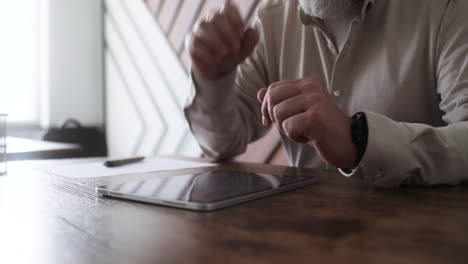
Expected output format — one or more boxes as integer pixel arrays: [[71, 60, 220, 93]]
[[184, 18, 269, 160]]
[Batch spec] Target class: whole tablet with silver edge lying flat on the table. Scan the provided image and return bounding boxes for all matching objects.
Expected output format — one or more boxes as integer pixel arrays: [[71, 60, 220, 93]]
[[96, 171, 316, 211]]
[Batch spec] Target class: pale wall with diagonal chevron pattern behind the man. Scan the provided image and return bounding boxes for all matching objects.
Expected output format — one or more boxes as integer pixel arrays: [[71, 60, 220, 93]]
[[105, 0, 286, 164]]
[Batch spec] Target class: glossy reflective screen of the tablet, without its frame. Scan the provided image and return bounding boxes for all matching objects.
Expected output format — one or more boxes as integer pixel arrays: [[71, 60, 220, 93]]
[[106, 171, 312, 203]]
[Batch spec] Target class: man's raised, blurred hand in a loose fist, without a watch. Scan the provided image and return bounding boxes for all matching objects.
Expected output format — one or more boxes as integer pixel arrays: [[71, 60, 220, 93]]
[[186, 3, 259, 80]]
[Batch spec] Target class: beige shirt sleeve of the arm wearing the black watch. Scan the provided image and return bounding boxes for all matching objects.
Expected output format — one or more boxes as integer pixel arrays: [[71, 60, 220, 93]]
[[353, 0, 468, 187]]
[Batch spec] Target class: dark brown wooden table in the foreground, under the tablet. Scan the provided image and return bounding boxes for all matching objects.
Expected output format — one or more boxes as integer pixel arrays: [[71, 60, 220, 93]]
[[0, 158, 468, 264]]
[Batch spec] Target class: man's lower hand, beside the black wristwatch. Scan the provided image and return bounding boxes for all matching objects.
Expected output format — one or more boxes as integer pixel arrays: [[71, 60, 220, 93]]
[[257, 78, 358, 168]]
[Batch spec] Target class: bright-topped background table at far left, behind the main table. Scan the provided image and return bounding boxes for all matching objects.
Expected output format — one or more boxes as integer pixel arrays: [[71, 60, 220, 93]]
[[7, 137, 82, 160]]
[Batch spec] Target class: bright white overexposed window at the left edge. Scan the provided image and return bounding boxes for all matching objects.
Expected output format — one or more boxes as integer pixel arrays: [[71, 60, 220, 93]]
[[0, 0, 41, 124]]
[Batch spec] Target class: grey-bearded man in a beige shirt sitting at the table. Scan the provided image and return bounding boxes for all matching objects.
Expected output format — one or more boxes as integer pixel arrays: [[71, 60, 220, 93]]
[[185, 0, 468, 187]]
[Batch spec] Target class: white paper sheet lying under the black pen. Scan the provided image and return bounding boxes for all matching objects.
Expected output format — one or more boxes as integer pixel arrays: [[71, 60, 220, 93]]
[[38, 158, 217, 179]]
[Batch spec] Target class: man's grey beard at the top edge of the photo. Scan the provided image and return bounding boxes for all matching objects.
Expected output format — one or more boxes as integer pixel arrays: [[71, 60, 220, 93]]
[[299, 0, 355, 19]]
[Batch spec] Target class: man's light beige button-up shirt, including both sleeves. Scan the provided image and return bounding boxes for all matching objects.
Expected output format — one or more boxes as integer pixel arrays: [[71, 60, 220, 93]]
[[185, 0, 468, 187]]
